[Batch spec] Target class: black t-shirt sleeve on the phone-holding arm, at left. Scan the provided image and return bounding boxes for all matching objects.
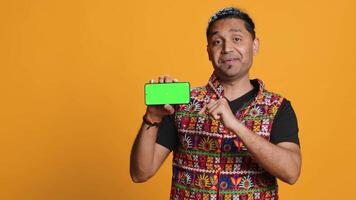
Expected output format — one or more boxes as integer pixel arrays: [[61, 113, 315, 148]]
[[156, 115, 177, 151]]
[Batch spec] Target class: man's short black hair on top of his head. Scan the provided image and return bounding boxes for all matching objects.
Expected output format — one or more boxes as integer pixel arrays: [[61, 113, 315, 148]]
[[206, 7, 256, 39]]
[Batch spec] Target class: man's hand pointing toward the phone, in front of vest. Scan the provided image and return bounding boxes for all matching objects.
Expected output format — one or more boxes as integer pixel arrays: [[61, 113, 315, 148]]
[[199, 98, 239, 130]]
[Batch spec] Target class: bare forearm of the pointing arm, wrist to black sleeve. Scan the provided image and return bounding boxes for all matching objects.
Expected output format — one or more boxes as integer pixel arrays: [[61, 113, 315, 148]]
[[232, 122, 300, 184]]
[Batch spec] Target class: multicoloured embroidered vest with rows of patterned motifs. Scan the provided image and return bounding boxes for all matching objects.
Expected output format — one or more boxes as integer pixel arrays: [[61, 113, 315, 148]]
[[170, 75, 283, 200]]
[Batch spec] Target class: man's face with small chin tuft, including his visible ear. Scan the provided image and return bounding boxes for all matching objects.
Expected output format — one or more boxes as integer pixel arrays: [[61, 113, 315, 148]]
[[207, 18, 259, 80]]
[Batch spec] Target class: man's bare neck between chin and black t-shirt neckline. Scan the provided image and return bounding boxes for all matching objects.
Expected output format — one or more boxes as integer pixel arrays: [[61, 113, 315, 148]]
[[220, 75, 253, 101]]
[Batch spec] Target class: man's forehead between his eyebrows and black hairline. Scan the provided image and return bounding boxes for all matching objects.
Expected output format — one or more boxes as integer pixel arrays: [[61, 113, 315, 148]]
[[211, 18, 247, 35]]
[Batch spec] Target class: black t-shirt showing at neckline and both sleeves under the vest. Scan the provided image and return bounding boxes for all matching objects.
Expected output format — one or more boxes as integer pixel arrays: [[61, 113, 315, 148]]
[[156, 80, 299, 151]]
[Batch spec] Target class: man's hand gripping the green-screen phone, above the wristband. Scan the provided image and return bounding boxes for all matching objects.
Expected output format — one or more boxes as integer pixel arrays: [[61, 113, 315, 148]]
[[146, 75, 178, 122]]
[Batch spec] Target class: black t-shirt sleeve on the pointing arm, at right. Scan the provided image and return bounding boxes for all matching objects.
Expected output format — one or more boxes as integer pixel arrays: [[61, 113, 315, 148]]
[[270, 99, 300, 145]]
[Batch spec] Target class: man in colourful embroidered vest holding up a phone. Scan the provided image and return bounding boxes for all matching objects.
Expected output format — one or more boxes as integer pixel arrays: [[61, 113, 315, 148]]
[[130, 8, 301, 199]]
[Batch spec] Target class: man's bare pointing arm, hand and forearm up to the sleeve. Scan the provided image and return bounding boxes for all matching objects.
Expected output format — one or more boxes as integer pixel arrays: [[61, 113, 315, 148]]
[[199, 98, 301, 184]]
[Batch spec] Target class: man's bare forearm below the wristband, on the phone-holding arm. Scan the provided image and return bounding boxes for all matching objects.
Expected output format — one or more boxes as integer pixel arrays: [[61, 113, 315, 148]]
[[130, 123, 158, 182]]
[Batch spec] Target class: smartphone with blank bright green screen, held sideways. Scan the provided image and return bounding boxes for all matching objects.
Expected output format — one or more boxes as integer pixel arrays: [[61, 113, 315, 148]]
[[145, 82, 190, 106]]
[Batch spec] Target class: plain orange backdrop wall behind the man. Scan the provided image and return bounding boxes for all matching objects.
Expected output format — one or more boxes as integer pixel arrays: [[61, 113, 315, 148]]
[[0, 0, 356, 200]]
